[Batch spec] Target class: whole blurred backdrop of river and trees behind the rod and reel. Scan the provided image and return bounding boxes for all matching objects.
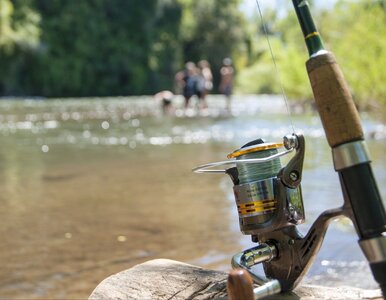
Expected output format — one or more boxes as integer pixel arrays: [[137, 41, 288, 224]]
[[0, 0, 386, 299]]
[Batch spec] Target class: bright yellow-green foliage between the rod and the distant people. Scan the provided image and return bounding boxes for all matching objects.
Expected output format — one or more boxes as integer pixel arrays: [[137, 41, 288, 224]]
[[237, 9, 311, 100]]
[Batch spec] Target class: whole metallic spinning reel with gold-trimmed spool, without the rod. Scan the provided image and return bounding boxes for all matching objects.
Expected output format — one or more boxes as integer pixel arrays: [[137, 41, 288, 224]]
[[193, 134, 350, 299]]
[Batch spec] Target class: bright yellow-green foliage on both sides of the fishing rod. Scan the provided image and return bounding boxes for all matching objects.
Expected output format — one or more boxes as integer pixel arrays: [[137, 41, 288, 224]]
[[238, 0, 386, 107]]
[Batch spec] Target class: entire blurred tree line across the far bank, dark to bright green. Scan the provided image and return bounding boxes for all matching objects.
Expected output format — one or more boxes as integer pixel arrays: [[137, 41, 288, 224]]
[[0, 0, 386, 108]]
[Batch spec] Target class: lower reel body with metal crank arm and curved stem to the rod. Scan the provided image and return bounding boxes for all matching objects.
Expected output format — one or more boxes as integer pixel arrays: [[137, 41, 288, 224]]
[[232, 207, 348, 292]]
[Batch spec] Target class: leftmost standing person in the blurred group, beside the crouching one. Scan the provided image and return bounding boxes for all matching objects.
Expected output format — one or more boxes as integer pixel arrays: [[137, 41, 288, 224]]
[[175, 61, 198, 108]]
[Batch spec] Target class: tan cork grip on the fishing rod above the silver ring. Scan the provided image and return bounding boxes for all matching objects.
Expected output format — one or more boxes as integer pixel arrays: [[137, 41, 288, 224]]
[[307, 53, 363, 148]]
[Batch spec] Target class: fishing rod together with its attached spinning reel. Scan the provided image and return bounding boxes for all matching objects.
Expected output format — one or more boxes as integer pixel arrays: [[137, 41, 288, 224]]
[[193, 0, 386, 299]]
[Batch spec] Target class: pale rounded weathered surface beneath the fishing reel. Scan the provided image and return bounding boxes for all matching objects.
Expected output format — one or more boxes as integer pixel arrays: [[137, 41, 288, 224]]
[[89, 259, 382, 300]]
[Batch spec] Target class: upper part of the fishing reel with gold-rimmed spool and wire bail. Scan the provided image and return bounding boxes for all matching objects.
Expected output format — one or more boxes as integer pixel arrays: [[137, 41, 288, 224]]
[[193, 135, 304, 239]]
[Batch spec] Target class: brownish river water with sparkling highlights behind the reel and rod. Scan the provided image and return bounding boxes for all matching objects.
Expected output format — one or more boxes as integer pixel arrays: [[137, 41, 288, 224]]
[[0, 96, 386, 299]]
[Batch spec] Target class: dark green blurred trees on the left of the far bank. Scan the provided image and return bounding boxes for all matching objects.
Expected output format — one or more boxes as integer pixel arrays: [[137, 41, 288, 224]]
[[0, 0, 243, 97]]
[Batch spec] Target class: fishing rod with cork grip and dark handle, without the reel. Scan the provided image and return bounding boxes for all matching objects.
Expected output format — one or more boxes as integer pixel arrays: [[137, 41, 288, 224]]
[[292, 0, 386, 298]]
